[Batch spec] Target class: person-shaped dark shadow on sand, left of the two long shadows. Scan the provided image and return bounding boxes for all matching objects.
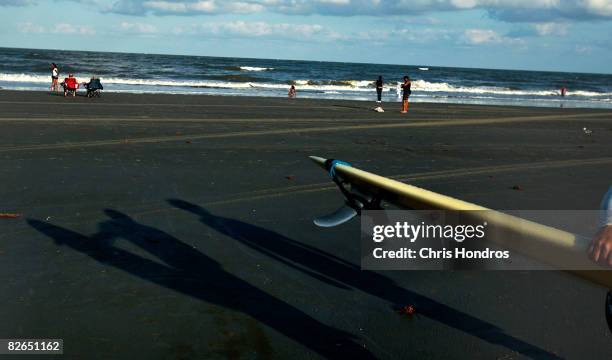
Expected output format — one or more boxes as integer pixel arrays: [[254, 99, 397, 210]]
[[28, 210, 374, 359]]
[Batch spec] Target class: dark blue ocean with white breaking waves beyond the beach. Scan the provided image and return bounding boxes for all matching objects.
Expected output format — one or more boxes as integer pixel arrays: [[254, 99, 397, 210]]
[[0, 48, 612, 108]]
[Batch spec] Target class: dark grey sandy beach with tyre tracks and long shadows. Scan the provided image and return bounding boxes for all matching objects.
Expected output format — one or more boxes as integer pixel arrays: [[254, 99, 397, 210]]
[[0, 90, 612, 359]]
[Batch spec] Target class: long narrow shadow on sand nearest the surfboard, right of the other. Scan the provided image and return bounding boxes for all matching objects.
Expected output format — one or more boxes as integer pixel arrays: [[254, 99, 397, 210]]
[[168, 199, 559, 359]]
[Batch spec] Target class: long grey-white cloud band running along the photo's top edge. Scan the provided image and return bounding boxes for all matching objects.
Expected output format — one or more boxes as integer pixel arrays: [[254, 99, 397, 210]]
[[100, 0, 612, 22]]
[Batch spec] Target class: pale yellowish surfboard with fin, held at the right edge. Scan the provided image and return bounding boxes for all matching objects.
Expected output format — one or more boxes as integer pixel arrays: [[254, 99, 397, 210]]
[[310, 156, 612, 288]]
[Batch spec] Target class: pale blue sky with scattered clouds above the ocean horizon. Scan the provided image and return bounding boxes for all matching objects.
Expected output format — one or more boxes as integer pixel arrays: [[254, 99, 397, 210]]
[[0, 0, 612, 73]]
